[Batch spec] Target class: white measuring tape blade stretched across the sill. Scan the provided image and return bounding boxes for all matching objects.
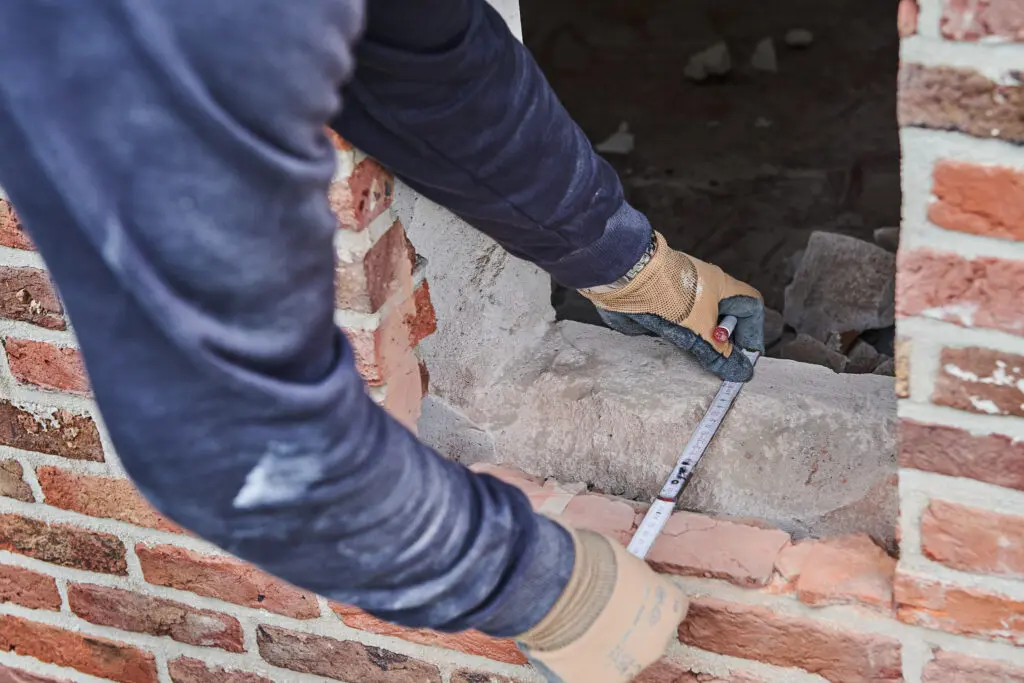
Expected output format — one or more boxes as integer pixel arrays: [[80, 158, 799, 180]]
[[627, 351, 760, 559]]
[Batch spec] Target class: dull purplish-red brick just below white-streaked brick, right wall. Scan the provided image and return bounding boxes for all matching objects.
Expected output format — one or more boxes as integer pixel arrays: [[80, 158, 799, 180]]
[[899, 420, 1024, 490]]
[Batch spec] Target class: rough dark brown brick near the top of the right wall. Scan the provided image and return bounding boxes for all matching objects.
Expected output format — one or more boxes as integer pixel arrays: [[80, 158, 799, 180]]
[[897, 62, 1024, 142]]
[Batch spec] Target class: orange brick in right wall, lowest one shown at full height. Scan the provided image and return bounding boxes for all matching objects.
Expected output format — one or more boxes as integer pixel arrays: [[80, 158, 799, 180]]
[[895, 570, 1024, 645]]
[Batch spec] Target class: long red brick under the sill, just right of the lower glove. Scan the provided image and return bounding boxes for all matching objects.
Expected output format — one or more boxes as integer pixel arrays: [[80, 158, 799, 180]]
[[679, 598, 902, 683]]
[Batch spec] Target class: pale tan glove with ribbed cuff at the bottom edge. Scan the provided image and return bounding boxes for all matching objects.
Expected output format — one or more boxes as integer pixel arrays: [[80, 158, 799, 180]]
[[516, 530, 688, 683]]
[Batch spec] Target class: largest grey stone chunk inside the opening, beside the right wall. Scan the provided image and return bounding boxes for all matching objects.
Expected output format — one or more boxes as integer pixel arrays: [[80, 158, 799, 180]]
[[782, 231, 896, 341]]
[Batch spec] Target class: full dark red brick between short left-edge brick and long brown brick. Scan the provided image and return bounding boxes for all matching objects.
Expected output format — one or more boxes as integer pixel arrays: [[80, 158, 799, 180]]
[[68, 584, 245, 652]]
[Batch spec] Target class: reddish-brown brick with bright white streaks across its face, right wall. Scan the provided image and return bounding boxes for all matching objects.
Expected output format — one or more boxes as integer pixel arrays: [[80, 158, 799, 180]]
[[932, 347, 1024, 416]]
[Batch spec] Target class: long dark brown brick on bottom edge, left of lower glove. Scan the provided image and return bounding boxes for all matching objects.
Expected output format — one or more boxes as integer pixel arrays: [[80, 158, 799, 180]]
[[256, 626, 441, 683]]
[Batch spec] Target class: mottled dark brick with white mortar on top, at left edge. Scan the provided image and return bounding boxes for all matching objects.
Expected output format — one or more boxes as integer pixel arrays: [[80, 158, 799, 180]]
[[0, 400, 103, 463]]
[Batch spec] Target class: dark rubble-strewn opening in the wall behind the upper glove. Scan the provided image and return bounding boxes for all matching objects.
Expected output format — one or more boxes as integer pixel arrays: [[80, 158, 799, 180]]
[[521, 0, 900, 375]]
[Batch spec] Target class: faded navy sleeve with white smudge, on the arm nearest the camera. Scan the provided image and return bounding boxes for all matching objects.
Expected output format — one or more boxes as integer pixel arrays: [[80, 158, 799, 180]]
[[0, 0, 573, 636]]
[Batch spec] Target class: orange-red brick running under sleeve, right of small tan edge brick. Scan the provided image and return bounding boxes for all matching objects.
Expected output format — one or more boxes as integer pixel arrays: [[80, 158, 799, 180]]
[[36, 467, 181, 531]]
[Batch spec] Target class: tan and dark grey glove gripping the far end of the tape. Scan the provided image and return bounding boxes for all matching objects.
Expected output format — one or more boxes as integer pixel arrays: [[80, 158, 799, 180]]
[[580, 232, 764, 382]]
